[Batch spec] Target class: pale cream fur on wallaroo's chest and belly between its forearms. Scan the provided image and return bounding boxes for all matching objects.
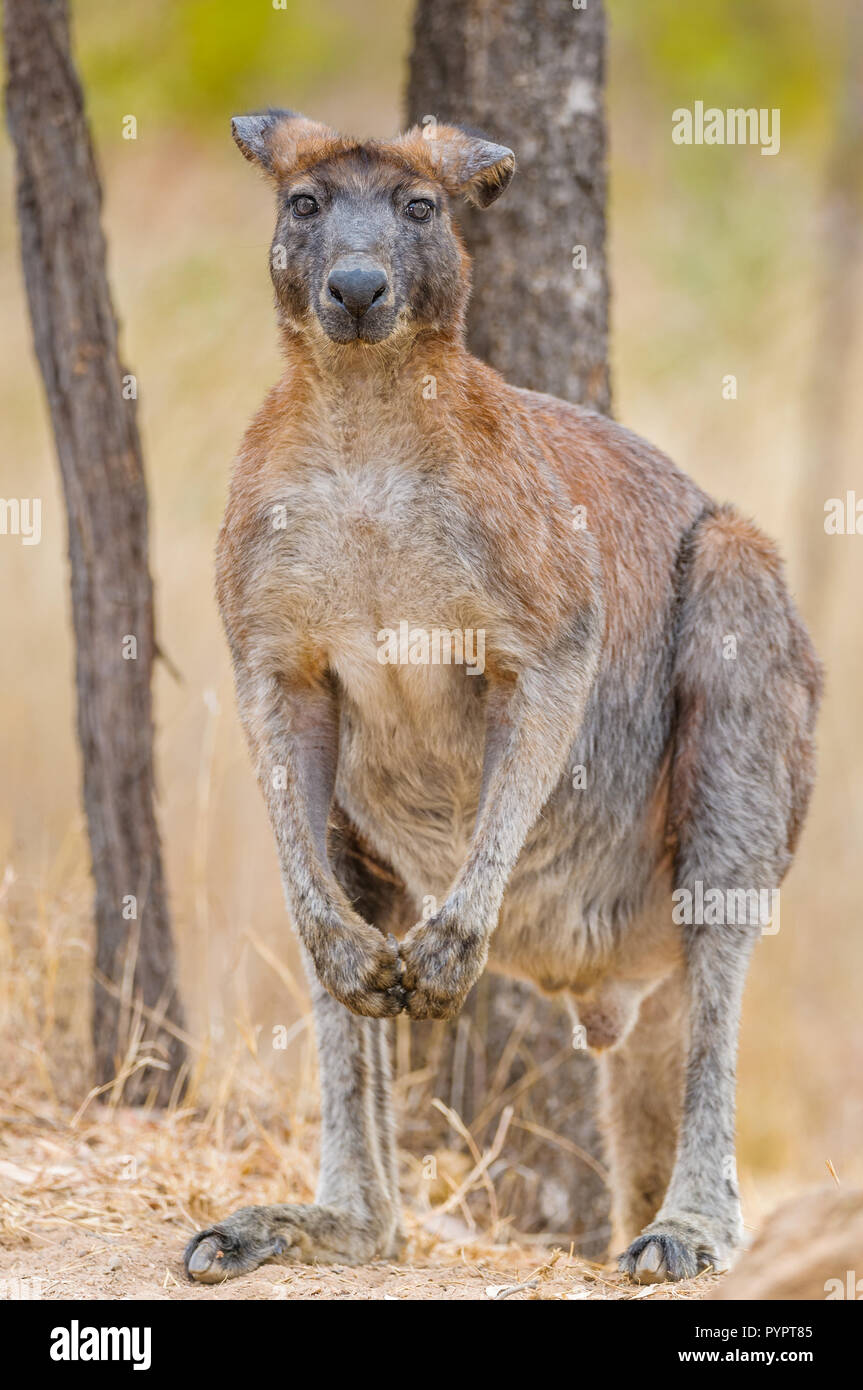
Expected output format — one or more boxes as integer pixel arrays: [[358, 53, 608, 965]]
[[248, 436, 496, 892]]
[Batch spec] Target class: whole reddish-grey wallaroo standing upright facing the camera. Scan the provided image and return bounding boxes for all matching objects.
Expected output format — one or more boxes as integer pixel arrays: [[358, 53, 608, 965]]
[[186, 111, 820, 1282]]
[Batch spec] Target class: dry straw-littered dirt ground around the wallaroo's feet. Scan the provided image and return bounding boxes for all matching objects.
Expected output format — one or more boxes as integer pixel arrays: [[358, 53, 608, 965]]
[[0, 1097, 718, 1301]]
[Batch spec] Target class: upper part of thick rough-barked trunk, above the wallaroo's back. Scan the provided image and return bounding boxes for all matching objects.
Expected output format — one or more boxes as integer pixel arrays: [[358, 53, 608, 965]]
[[407, 0, 610, 411]]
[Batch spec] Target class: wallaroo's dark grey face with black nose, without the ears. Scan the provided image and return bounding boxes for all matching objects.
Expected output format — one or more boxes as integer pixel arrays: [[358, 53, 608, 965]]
[[271, 152, 463, 343]]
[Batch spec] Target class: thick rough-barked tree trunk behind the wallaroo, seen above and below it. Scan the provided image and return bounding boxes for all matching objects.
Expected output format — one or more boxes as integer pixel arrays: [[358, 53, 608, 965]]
[[399, 0, 610, 1255]]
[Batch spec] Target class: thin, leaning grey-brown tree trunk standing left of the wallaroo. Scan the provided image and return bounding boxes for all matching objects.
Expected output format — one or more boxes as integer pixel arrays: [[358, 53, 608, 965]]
[[6, 0, 185, 1102]]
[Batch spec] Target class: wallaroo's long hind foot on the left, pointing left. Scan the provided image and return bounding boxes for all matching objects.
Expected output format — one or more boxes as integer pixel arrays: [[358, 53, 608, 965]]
[[185, 1205, 400, 1284]]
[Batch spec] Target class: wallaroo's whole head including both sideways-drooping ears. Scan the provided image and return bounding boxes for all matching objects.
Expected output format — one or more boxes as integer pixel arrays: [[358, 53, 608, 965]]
[[232, 111, 516, 343]]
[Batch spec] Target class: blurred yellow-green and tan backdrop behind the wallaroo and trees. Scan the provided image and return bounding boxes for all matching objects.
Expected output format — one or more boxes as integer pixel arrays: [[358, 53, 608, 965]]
[[0, 0, 863, 1234]]
